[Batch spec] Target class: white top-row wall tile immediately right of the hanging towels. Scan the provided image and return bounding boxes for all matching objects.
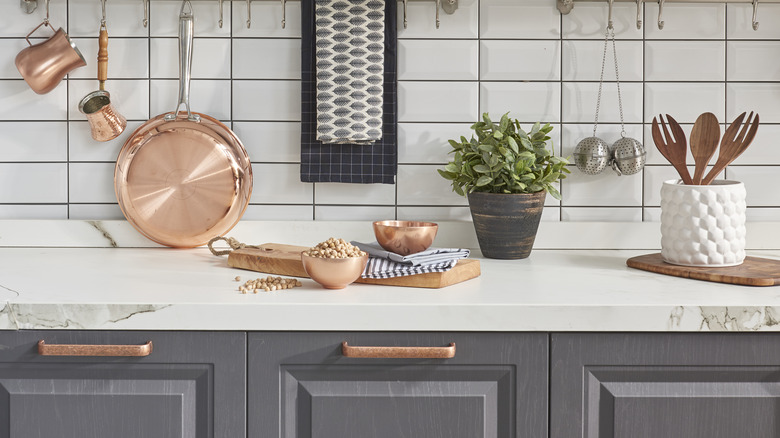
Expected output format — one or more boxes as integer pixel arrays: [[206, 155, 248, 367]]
[[398, 0, 479, 39]]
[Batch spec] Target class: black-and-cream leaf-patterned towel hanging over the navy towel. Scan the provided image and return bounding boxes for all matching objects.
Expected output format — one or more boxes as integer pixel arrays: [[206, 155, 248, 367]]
[[315, 0, 382, 144]]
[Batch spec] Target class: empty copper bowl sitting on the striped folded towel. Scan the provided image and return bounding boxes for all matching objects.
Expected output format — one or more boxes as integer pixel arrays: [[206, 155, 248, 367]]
[[374, 221, 439, 256]]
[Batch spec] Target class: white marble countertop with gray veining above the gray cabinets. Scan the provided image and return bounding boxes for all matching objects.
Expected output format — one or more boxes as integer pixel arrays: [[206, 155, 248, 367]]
[[0, 247, 780, 331]]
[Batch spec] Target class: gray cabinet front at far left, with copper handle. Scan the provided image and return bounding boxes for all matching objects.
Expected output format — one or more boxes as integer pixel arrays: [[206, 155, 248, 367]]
[[0, 331, 246, 438]]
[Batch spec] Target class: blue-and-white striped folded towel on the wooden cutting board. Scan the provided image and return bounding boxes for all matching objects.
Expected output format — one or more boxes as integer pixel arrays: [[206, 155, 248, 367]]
[[350, 241, 470, 278]]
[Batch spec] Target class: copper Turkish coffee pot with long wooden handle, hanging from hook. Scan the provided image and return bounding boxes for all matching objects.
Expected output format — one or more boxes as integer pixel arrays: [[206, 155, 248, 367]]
[[79, 0, 127, 141]]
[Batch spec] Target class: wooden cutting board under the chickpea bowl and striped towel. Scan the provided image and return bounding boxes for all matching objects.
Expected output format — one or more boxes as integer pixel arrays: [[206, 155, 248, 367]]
[[228, 243, 481, 288]]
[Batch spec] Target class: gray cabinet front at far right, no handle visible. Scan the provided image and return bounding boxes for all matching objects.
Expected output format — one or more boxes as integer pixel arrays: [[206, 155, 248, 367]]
[[550, 333, 780, 438]]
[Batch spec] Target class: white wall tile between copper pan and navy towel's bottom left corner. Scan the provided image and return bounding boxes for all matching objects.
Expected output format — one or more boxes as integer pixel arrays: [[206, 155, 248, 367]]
[[250, 164, 314, 204]]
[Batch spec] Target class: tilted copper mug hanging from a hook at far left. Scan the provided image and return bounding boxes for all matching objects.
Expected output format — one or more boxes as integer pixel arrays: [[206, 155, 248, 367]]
[[15, 21, 87, 94]]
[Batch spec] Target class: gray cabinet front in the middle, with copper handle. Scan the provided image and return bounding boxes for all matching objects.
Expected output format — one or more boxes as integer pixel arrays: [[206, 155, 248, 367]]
[[248, 333, 548, 438]]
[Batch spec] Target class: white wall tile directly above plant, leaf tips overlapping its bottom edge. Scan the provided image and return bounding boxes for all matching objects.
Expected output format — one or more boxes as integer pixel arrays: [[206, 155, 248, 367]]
[[479, 82, 561, 123]]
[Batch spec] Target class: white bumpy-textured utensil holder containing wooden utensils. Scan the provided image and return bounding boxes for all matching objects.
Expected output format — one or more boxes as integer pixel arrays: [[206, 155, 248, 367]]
[[661, 180, 747, 266]]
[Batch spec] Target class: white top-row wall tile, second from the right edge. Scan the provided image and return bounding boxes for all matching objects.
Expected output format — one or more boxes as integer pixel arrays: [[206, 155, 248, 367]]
[[643, 3, 726, 40]]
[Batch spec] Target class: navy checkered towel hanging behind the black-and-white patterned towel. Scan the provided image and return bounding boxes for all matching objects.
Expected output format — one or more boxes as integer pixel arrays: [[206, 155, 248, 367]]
[[301, 0, 398, 184]]
